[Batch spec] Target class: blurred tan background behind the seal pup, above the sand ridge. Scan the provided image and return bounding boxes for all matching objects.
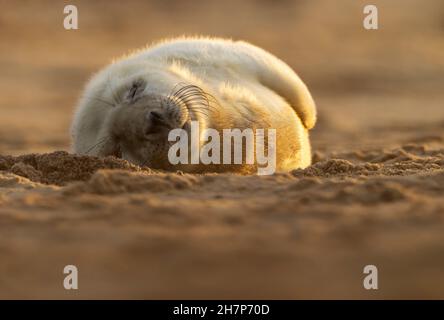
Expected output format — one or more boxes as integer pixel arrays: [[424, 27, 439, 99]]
[[0, 0, 444, 154]]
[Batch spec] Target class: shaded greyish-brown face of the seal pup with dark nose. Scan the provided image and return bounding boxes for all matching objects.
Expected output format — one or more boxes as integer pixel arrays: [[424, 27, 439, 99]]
[[108, 81, 190, 169]]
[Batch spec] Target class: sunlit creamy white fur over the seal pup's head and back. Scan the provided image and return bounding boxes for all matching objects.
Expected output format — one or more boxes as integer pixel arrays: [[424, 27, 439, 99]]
[[71, 38, 316, 170]]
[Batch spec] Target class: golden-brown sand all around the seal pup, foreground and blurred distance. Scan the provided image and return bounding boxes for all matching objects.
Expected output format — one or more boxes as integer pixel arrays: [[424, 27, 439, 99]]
[[0, 0, 444, 299]]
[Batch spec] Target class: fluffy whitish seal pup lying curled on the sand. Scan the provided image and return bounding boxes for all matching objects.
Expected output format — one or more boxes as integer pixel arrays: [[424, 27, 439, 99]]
[[72, 38, 316, 173]]
